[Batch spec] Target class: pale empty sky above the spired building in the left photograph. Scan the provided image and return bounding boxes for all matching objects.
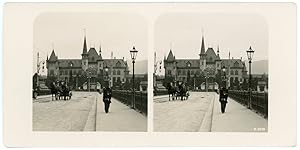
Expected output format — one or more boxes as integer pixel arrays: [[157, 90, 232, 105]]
[[33, 12, 148, 74]]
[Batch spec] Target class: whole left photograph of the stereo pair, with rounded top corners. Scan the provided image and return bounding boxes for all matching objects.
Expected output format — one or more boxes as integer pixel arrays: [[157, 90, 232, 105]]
[[32, 12, 148, 132]]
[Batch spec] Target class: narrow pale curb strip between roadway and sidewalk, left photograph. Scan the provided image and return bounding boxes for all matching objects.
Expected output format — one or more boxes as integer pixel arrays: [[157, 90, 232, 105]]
[[83, 95, 98, 131]]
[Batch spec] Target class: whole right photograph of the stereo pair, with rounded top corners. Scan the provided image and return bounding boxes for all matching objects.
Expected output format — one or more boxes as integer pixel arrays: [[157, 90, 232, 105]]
[[153, 12, 268, 132]]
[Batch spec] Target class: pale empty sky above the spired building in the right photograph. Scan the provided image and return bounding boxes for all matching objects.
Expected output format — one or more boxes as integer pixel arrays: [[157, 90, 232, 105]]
[[154, 13, 268, 74]]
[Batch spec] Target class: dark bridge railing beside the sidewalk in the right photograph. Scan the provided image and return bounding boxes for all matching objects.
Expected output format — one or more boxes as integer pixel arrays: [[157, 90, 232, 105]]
[[228, 90, 268, 118]]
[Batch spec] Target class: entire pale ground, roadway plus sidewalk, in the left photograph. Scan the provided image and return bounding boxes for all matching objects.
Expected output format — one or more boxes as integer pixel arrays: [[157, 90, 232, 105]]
[[32, 92, 147, 132]]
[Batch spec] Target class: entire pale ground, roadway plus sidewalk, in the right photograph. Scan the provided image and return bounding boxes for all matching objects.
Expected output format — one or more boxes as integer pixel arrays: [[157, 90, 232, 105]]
[[154, 93, 268, 132]]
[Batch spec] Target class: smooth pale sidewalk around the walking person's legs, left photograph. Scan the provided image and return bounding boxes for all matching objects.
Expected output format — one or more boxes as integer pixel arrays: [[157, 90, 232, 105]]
[[96, 94, 147, 132]]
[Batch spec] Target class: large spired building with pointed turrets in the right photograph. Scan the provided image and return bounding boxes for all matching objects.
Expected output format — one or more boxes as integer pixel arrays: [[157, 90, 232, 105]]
[[164, 37, 247, 89]]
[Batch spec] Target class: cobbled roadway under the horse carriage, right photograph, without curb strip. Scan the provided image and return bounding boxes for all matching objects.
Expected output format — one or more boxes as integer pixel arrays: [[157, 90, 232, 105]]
[[153, 92, 215, 132]]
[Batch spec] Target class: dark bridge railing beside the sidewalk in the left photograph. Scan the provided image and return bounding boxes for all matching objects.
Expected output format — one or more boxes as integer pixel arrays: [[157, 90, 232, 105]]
[[112, 90, 148, 115]]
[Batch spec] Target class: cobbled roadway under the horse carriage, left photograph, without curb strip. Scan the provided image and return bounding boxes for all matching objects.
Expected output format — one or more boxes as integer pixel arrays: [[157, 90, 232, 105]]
[[32, 92, 97, 131]]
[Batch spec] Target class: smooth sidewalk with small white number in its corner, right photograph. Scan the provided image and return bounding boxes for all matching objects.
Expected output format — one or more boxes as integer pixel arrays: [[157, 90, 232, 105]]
[[211, 95, 268, 132]]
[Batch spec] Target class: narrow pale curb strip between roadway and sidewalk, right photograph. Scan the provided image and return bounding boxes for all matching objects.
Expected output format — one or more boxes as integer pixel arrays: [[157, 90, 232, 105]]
[[198, 95, 216, 132]]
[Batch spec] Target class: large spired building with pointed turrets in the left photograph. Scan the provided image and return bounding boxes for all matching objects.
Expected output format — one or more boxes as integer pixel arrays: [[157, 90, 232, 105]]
[[46, 36, 129, 88]]
